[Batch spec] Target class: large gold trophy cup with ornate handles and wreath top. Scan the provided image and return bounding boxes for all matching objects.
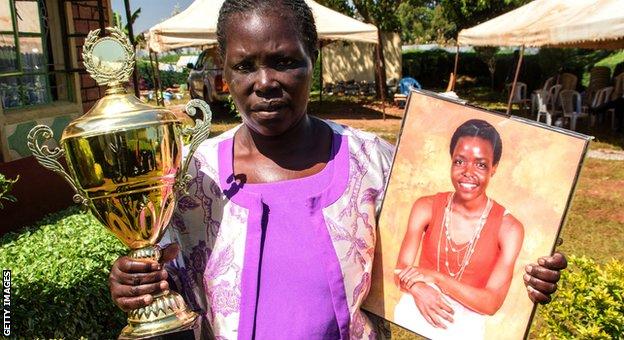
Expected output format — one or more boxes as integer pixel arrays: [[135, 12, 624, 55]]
[[28, 28, 212, 339]]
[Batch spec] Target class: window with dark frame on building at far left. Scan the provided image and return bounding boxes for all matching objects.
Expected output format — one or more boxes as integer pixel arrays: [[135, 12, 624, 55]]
[[0, 0, 69, 110]]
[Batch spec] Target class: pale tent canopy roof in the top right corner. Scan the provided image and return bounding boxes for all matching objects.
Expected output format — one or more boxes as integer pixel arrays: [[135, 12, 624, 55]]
[[457, 0, 624, 49]]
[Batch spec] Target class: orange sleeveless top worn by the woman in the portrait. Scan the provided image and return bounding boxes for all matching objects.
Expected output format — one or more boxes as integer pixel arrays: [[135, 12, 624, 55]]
[[418, 192, 505, 288]]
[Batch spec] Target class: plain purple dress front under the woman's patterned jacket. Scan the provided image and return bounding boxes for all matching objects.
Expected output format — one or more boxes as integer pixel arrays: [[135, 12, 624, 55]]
[[219, 134, 349, 339]]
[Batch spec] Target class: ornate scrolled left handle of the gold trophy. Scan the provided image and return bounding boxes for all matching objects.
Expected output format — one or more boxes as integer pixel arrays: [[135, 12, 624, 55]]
[[27, 125, 88, 206]]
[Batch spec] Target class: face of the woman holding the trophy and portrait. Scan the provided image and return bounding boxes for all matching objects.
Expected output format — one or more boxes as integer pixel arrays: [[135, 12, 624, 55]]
[[224, 11, 313, 136]]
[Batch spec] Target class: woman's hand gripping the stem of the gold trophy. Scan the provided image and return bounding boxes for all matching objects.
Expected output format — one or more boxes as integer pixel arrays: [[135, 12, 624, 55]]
[[108, 243, 180, 312]]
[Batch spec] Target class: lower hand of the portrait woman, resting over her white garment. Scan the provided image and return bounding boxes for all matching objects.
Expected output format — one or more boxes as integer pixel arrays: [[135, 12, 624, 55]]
[[409, 282, 454, 329]]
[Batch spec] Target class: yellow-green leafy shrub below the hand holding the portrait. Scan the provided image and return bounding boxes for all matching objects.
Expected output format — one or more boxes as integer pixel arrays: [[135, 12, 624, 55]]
[[540, 256, 624, 339]]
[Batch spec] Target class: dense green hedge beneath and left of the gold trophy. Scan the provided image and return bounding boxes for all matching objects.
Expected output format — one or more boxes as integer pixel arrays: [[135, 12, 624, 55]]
[[0, 208, 128, 339]]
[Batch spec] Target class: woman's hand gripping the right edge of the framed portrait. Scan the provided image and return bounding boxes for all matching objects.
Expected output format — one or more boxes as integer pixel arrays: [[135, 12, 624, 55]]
[[524, 252, 568, 304]]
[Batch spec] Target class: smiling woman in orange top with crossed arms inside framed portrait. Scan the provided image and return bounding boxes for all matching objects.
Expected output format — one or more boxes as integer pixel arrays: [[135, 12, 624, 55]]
[[395, 119, 524, 339]]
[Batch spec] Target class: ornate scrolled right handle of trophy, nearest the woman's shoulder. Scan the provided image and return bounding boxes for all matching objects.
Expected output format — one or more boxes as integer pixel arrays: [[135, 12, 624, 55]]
[[176, 99, 212, 194]]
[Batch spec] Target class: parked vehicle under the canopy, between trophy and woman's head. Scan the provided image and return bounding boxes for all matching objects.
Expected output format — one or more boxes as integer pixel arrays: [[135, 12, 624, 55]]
[[187, 48, 229, 104]]
